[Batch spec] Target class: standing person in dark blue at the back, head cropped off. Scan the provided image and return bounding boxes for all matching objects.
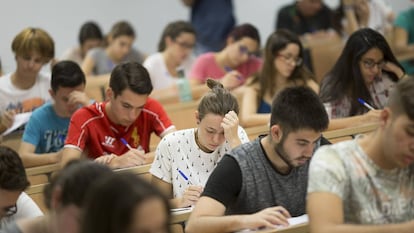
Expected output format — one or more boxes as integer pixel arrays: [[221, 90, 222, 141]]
[[182, 0, 236, 56]]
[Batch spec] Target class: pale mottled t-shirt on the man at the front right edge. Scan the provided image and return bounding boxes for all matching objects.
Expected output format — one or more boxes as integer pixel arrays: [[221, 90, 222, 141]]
[[308, 137, 414, 224]]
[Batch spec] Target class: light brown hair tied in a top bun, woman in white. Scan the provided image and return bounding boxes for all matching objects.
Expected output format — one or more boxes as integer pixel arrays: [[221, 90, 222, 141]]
[[197, 79, 239, 120]]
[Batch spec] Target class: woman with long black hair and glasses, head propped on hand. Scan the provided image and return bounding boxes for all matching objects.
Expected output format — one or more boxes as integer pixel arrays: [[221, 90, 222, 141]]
[[320, 28, 405, 129]]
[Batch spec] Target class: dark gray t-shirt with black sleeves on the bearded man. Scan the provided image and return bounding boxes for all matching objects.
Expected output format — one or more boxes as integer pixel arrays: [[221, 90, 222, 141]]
[[203, 137, 309, 216]]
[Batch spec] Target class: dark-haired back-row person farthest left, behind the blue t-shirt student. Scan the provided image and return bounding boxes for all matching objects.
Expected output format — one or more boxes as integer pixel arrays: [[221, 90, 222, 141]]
[[60, 21, 104, 66]]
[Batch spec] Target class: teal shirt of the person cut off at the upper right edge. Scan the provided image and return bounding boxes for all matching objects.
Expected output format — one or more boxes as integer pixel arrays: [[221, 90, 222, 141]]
[[394, 7, 414, 75]]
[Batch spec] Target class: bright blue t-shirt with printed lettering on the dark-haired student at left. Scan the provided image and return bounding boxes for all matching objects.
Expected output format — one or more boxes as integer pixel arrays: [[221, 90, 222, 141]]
[[23, 103, 70, 154]]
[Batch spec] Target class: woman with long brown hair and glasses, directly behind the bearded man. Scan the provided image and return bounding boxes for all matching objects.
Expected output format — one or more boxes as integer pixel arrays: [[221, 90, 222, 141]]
[[240, 29, 319, 127]]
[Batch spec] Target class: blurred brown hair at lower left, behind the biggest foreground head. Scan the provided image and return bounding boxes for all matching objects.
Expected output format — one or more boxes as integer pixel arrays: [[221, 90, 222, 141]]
[[43, 160, 112, 209]]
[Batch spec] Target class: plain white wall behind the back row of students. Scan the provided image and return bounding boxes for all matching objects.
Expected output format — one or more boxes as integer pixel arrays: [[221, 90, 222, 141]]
[[0, 0, 410, 72]]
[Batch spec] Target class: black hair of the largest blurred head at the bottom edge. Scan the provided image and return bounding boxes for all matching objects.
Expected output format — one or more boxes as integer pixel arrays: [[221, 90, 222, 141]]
[[81, 173, 170, 233]]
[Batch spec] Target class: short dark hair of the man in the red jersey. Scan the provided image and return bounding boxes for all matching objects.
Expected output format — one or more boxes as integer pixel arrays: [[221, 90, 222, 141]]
[[109, 61, 153, 97]]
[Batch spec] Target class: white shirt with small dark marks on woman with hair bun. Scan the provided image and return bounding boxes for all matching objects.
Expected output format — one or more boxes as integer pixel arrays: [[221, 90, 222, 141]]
[[150, 126, 249, 198]]
